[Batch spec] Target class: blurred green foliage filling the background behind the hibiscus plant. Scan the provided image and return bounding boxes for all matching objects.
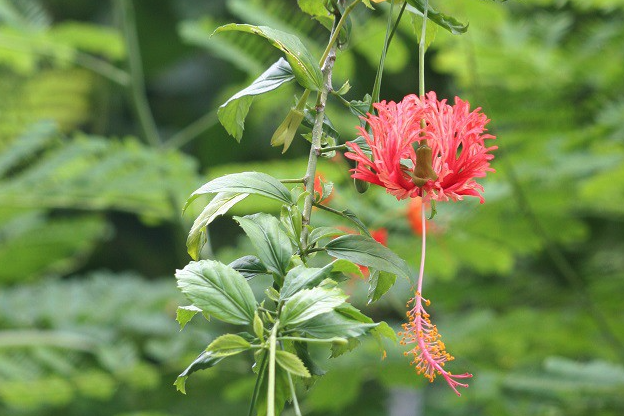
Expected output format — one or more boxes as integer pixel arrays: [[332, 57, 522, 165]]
[[0, 0, 624, 416]]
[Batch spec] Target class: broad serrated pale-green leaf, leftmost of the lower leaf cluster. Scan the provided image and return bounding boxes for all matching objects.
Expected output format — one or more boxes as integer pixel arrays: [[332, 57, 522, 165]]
[[176, 260, 256, 325]]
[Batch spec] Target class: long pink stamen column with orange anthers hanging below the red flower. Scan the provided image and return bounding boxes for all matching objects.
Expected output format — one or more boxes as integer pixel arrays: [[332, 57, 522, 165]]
[[399, 203, 472, 396]]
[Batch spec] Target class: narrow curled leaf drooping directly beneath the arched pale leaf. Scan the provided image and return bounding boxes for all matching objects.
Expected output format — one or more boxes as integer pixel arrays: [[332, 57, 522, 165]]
[[186, 192, 249, 260]]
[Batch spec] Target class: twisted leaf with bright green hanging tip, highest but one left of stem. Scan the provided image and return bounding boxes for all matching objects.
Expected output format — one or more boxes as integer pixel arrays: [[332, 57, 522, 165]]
[[217, 58, 295, 142]]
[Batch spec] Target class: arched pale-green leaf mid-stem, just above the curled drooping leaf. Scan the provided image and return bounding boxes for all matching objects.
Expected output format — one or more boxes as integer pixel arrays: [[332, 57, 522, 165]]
[[184, 172, 295, 209]]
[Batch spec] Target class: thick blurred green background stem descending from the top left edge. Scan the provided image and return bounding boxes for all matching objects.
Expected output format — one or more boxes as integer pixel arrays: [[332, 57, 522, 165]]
[[115, 0, 160, 147]]
